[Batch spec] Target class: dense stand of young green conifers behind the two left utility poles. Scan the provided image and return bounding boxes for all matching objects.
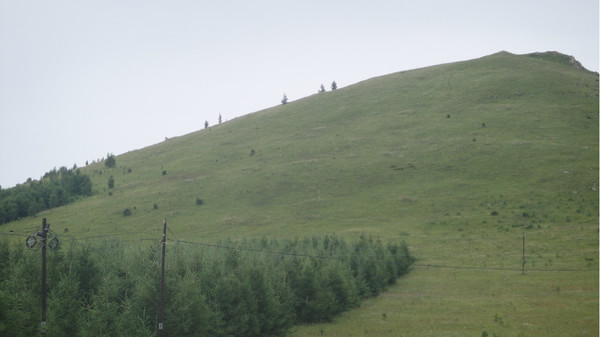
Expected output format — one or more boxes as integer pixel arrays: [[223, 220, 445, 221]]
[[0, 235, 414, 337]]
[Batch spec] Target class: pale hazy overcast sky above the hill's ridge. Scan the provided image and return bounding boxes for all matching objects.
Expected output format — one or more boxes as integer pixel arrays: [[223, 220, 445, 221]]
[[0, 0, 599, 188]]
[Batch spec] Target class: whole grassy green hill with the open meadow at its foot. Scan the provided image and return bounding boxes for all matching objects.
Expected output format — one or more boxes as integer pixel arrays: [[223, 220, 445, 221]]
[[0, 52, 599, 336]]
